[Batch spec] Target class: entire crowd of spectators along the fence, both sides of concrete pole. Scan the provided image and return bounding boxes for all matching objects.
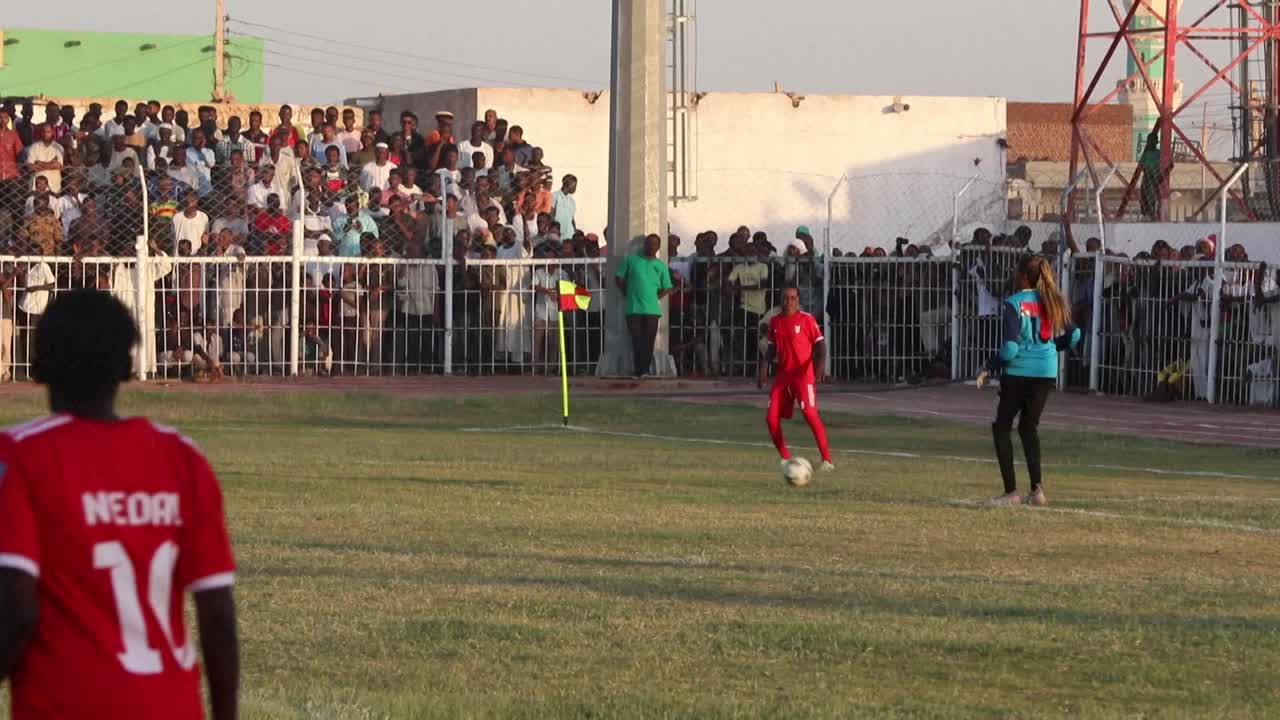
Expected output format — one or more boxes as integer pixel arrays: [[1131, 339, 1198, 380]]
[[0, 94, 1280, 404]]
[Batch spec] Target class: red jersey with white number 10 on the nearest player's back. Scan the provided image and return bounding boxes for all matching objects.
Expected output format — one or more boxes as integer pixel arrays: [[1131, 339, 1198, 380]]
[[0, 415, 234, 720]]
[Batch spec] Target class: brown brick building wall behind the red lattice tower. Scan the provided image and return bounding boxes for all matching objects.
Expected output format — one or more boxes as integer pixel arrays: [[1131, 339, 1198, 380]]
[[1006, 102, 1133, 163]]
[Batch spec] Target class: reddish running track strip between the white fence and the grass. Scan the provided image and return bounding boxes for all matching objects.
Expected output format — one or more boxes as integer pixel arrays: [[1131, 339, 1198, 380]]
[[0, 375, 1280, 448]]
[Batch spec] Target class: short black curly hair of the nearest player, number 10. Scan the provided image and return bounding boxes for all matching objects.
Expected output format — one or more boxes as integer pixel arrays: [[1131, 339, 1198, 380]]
[[31, 290, 140, 398]]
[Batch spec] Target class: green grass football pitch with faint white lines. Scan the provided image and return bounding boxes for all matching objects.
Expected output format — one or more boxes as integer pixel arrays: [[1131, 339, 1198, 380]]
[[0, 391, 1280, 719]]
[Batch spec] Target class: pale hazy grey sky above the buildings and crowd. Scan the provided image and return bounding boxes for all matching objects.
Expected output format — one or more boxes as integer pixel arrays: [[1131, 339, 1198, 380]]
[[0, 0, 1230, 154]]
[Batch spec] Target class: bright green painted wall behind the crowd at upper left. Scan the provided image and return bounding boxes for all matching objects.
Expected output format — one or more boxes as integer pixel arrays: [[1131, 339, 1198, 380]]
[[0, 28, 262, 104]]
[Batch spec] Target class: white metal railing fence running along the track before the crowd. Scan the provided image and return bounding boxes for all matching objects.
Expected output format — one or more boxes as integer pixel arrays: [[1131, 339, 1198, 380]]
[[0, 240, 1280, 407]]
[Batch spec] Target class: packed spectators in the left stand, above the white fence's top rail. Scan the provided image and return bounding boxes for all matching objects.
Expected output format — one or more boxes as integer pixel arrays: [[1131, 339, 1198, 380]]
[[0, 99, 589, 258]]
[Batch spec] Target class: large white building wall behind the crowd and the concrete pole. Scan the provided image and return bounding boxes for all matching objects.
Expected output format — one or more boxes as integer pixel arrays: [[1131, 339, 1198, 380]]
[[349, 88, 1005, 251]]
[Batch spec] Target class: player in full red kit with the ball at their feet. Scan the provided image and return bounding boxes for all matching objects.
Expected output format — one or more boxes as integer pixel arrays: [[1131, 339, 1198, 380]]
[[758, 287, 836, 470]]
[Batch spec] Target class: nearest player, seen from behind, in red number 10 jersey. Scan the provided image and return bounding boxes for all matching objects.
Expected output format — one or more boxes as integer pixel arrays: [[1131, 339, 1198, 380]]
[[0, 291, 239, 720]]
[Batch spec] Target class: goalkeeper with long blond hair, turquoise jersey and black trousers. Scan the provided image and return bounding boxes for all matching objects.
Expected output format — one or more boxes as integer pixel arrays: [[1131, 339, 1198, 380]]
[[978, 255, 1080, 505]]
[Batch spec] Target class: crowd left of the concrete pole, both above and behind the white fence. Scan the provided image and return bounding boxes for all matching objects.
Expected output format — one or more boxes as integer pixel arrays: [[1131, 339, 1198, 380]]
[[0, 99, 603, 377]]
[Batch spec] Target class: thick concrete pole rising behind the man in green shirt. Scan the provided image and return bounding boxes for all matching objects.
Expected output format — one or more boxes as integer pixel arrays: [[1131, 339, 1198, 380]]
[[595, 0, 676, 377]]
